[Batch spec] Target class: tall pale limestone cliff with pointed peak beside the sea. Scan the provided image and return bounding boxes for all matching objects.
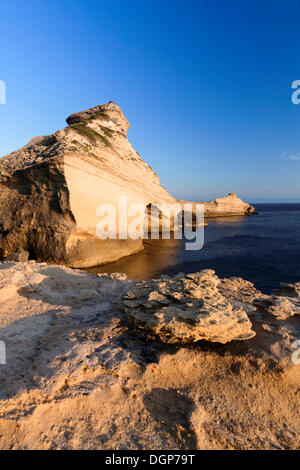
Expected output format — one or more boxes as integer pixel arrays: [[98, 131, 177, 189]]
[[0, 102, 175, 267]]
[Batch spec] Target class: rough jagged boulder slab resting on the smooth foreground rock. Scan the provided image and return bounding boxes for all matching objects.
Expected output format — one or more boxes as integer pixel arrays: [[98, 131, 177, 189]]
[[123, 270, 255, 344]]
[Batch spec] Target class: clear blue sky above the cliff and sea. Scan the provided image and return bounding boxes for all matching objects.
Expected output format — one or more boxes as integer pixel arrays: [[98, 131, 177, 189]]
[[0, 0, 300, 202]]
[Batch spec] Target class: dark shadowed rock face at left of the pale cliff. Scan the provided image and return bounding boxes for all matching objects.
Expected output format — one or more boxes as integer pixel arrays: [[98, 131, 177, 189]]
[[0, 159, 76, 263]]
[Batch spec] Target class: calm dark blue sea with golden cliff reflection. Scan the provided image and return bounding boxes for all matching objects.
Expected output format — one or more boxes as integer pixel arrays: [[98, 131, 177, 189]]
[[89, 204, 300, 293]]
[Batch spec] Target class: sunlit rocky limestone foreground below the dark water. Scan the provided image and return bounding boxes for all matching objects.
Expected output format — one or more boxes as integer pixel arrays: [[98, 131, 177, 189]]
[[0, 262, 300, 449]]
